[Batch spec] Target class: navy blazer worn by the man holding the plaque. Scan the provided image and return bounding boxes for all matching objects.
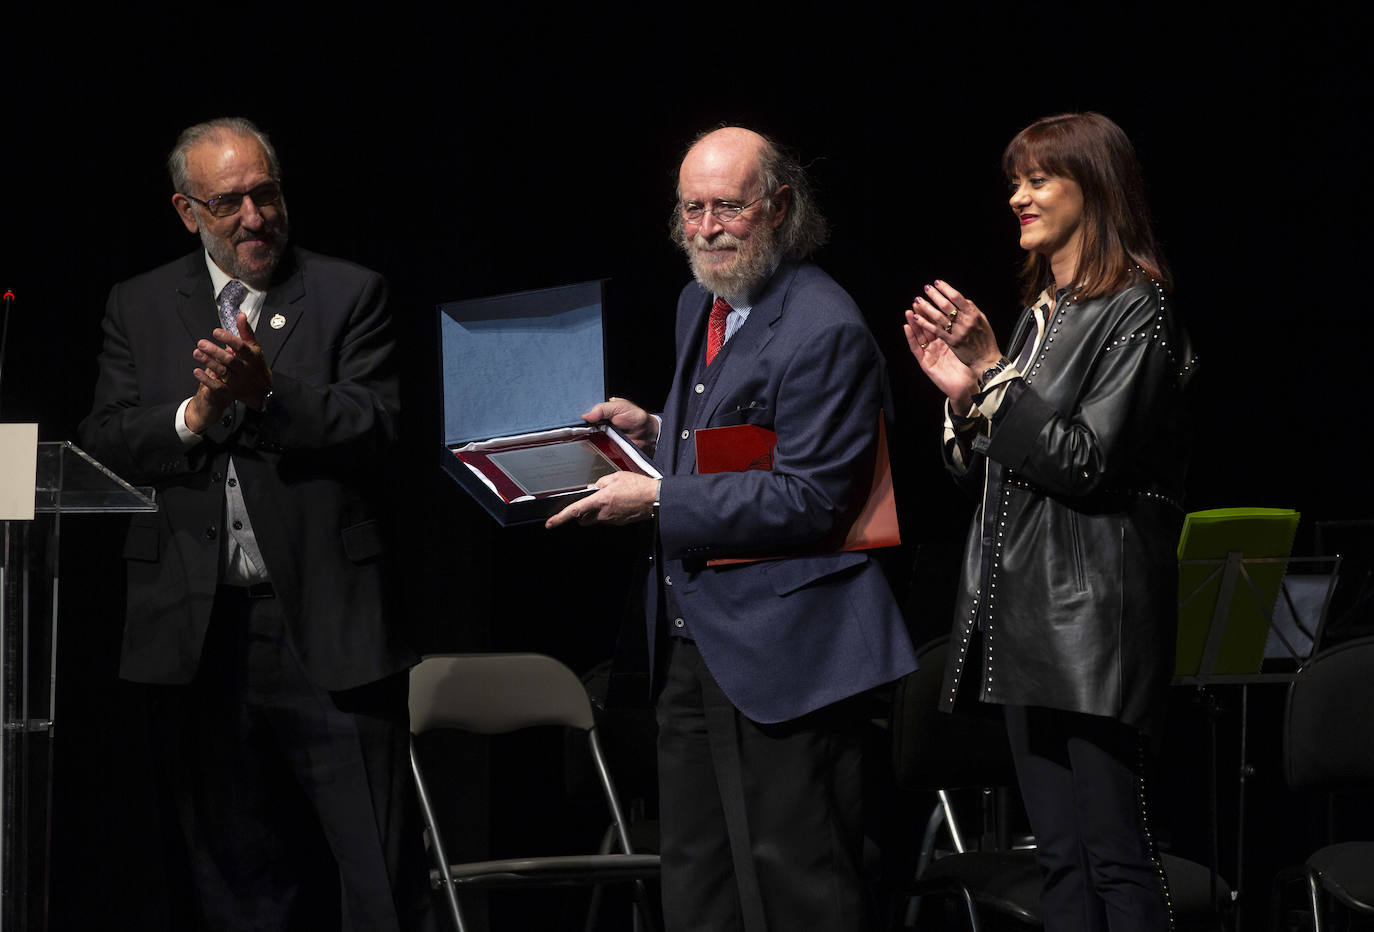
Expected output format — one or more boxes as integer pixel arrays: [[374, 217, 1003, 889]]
[[649, 264, 915, 722]]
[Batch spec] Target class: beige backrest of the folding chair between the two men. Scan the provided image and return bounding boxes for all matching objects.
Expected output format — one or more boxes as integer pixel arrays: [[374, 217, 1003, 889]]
[[411, 654, 595, 734]]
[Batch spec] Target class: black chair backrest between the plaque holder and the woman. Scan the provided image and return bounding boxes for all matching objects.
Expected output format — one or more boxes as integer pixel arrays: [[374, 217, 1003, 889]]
[[892, 638, 1017, 789]]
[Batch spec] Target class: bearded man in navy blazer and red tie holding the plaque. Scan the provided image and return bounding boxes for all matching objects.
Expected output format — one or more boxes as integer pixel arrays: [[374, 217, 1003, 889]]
[[548, 126, 915, 932]]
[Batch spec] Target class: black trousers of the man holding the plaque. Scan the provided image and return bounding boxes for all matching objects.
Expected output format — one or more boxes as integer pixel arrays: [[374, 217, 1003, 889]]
[[658, 641, 872, 932]]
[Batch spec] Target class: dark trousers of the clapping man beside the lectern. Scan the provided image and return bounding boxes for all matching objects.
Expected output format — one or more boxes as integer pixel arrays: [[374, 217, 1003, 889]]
[[150, 587, 431, 932]]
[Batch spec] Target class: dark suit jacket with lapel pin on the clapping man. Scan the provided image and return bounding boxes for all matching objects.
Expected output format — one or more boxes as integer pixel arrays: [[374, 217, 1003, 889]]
[[80, 250, 414, 689]]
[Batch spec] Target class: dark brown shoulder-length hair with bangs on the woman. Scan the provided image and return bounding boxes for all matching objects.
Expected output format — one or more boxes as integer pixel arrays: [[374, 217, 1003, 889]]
[[1002, 113, 1169, 304]]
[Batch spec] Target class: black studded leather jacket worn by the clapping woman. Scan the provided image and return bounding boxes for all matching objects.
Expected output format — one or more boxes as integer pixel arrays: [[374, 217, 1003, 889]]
[[943, 280, 1194, 729]]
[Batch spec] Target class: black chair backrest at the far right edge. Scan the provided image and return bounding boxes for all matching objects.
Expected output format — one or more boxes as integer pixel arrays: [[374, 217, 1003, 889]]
[[1283, 636, 1374, 789]]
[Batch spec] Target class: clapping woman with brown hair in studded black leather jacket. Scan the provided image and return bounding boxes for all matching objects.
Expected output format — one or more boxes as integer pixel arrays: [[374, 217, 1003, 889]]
[[904, 113, 1193, 932]]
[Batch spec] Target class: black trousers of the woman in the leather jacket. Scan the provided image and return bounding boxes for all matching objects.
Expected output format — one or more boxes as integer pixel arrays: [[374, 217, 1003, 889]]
[[1006, 705, 1171, 932]]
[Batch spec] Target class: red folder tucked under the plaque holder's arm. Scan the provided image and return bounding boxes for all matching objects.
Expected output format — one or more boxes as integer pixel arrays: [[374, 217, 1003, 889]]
[[697, 412, 901, 566]]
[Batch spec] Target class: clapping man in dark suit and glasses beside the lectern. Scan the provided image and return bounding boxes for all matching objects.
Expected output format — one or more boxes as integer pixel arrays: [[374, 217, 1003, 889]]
[[80, 118, 422, 931]]
